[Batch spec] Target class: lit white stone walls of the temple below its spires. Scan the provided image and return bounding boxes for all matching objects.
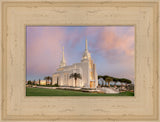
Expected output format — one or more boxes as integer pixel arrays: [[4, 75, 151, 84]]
[[52, 60, 98, 88]]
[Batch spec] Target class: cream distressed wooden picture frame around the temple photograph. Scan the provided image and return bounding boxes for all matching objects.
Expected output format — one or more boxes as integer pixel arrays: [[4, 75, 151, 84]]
[[0, 0, 160, 122]]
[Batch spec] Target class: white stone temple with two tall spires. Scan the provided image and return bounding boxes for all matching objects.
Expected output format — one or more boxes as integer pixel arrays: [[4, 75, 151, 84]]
[[52, 40, 98, 88]]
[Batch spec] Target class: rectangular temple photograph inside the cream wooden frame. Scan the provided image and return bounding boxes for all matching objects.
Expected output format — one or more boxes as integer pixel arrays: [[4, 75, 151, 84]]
[[26, 26, 135, 96]]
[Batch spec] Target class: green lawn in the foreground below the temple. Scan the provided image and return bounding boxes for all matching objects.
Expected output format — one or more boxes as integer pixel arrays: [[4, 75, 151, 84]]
[[26, 87, 134, 96]]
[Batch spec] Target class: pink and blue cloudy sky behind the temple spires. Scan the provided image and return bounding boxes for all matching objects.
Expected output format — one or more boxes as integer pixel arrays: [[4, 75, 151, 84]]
[[26, 26, 135, 81]]
